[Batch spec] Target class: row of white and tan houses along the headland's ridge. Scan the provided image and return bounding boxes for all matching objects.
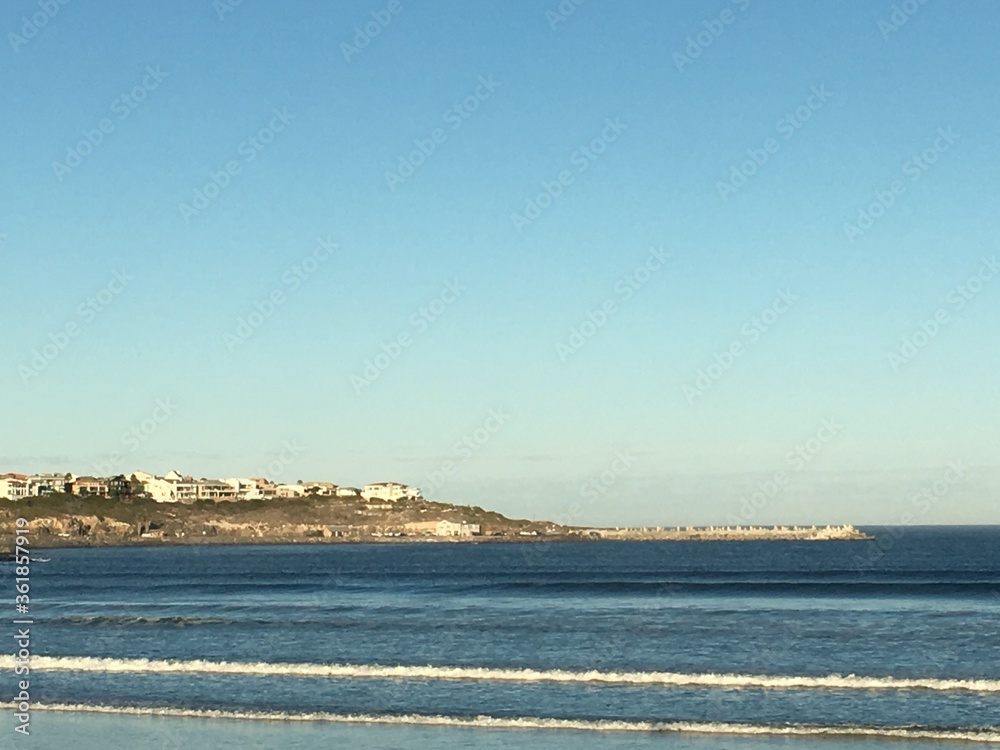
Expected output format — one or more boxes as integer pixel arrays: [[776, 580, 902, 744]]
[[0, 471, 422, 503]]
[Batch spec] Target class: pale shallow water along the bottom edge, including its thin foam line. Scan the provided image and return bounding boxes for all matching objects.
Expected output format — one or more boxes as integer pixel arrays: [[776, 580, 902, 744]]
[[11, 703, 996, 750]]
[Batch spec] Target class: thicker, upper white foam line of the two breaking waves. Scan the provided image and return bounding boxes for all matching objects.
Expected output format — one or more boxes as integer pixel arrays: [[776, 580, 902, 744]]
[[0, 655, 1000, 693]]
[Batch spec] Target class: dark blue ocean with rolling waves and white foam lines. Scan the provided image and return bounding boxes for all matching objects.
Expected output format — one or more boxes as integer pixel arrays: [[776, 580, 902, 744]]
[[0, 527, 1000, 750]]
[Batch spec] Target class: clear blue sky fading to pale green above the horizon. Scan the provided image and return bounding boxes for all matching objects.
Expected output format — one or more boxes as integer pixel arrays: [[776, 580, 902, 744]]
[[0, 0, 1000, 525]]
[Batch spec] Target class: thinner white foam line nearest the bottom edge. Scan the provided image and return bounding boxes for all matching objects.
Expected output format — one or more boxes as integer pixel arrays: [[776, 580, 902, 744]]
[[17, 704, 1000, 743]]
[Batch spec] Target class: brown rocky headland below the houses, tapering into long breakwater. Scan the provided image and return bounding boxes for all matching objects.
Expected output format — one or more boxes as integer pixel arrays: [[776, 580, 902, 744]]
[[0, 493, 871, 550]]
